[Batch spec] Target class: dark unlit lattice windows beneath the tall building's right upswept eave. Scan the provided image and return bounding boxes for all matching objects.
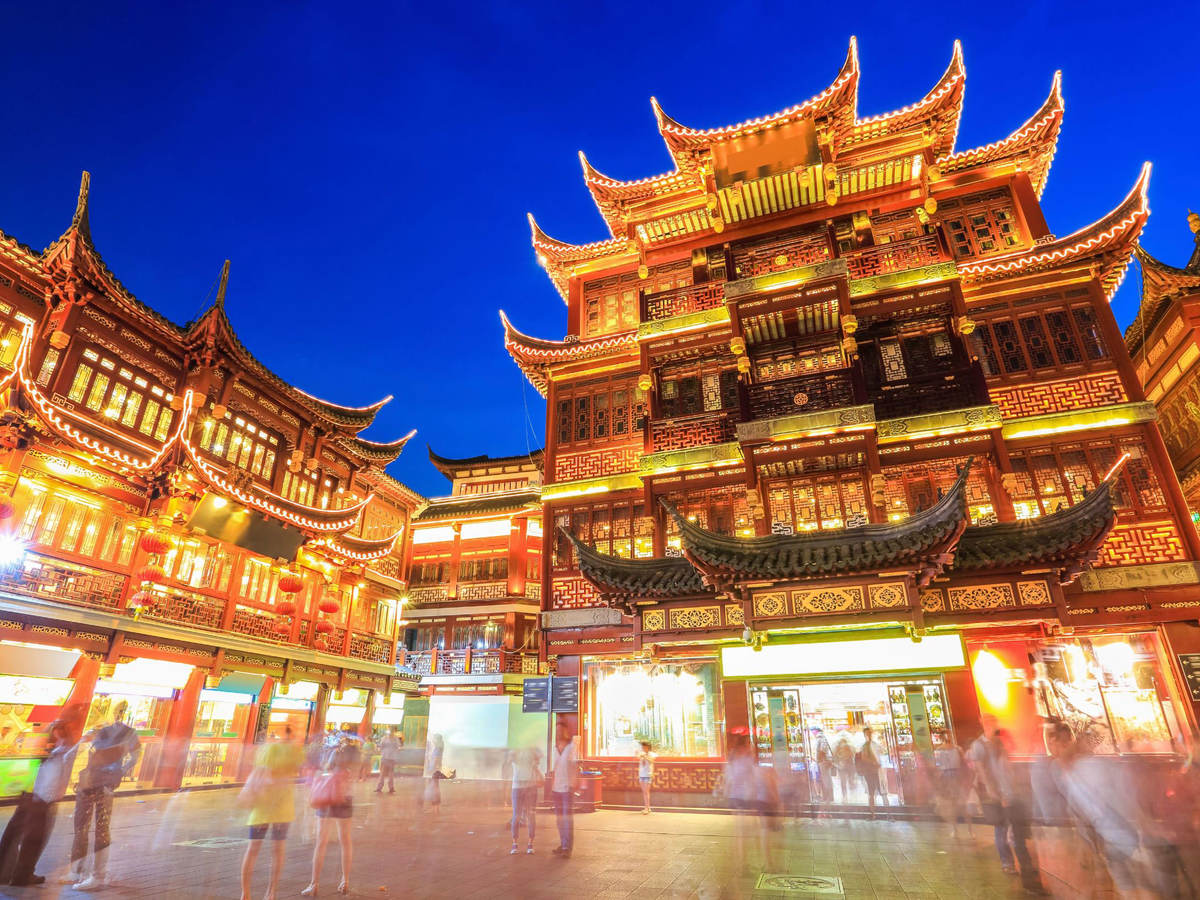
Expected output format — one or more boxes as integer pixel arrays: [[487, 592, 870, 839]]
[[971, 290, 1109, 377]]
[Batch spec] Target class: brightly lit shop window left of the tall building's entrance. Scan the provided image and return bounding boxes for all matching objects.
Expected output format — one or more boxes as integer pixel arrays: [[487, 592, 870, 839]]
[[584, 660, 722, 758]]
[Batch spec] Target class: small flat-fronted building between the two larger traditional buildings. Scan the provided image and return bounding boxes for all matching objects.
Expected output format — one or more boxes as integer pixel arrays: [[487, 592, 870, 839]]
[[397, 449, 546, 779]]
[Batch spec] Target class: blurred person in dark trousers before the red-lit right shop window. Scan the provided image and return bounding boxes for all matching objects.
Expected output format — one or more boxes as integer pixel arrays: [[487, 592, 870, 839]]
[[968, 715, 1045, 893]]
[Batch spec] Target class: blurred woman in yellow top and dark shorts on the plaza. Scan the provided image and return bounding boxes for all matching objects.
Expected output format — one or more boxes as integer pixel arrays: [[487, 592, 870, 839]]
[[241, 725, 304, 900]]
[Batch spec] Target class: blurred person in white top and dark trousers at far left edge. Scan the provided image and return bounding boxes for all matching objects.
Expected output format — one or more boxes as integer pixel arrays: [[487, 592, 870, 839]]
[[0, 721, 79, 887]]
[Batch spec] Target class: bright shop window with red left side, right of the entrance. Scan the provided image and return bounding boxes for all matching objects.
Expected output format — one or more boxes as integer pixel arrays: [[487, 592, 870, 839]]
[[968, 631, 1184, 756]]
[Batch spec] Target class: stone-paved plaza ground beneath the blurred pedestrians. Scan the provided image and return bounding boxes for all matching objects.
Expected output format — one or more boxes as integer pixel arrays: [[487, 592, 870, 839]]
[[0, 779, 1152, 900]]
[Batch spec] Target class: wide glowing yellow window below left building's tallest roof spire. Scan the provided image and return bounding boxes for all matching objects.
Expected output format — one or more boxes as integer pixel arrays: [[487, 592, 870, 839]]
[[66, 347, 175, 440]]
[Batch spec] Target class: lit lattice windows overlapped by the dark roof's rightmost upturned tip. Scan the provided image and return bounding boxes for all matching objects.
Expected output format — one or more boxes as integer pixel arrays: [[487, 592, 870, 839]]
[[1010, 437, 1166, 518]]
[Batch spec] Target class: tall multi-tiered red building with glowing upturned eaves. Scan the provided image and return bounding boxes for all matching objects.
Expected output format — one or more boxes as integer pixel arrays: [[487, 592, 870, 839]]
[[502, 42, 1200, 804]]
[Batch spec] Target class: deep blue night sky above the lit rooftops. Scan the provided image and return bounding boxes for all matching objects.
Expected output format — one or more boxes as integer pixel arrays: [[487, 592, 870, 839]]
[[0, 2, 1200, 494]]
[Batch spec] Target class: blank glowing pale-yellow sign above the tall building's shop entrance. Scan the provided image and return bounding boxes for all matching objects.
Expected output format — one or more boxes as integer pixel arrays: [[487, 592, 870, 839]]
[[721, 635, 966, 678]]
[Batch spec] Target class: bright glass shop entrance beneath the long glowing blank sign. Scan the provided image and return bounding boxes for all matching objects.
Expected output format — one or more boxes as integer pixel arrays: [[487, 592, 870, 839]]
[[750, 676, 949, 805]]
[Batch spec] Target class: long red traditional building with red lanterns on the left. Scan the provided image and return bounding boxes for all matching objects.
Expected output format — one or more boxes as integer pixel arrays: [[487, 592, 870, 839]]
[[0, 174, 420, 787]]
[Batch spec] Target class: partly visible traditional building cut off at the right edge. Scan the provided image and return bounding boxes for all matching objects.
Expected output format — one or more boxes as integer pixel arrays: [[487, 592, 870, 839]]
[[1126, 212, 1200, 520]]
